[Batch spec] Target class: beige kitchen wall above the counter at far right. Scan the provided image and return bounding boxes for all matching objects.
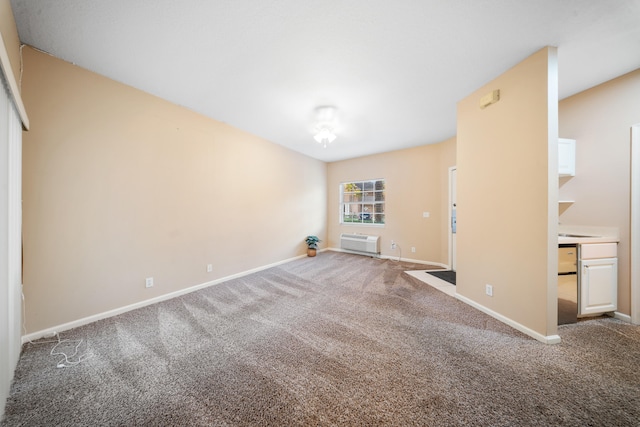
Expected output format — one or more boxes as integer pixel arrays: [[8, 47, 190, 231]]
[[559, 70, 640, 314]]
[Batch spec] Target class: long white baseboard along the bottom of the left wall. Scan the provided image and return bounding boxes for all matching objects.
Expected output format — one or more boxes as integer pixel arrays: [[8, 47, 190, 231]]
[[22, 255, 307, 344]]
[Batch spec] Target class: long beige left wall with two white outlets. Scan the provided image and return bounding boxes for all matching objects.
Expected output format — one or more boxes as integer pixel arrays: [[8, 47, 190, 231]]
[[23, 48, 327, 333]]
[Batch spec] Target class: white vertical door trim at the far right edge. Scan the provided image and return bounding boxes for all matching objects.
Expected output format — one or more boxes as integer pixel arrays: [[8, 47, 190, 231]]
[[629, 123, 640, 325]]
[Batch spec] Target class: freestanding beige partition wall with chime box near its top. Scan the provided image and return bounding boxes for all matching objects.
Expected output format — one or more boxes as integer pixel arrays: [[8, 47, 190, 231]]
[[456, 48, 558, 336]]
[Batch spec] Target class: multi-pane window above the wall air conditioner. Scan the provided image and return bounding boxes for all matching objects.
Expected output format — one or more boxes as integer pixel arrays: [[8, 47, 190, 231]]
[[340, 179, 385, 225]]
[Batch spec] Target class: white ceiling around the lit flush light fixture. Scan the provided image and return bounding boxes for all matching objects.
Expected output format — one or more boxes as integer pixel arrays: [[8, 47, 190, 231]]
[[11, 0, 640, 161]]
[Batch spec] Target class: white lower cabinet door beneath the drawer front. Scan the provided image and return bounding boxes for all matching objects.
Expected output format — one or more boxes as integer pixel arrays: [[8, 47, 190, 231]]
[[578, 258, 618, 316]]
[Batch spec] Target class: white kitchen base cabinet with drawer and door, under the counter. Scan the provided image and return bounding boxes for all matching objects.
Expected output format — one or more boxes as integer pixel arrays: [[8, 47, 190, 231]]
[[578, 243, 618, 317]]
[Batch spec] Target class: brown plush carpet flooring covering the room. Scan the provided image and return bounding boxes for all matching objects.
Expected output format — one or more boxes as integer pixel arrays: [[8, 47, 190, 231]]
[[0, 252, 640, 427]]
